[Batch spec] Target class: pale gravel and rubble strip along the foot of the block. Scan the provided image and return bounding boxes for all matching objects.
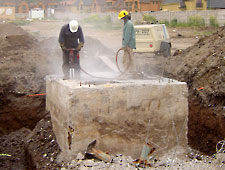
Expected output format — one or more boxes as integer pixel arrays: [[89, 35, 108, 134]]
[[57, 147, 225, 170]]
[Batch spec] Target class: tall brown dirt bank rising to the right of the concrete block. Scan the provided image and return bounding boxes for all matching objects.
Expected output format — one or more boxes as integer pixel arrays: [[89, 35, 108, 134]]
[[165, 27, 225, 154]]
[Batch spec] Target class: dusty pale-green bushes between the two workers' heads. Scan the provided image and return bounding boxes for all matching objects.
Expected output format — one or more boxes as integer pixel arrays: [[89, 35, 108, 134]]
[[80, 15, 121, 30]]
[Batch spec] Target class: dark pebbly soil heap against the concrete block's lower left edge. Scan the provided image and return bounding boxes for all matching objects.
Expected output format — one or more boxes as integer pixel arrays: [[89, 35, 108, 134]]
[[24, 115, 61, 169]]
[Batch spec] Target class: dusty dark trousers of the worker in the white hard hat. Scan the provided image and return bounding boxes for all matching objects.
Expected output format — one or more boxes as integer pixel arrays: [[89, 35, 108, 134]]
[[62, 51, 80, 79]]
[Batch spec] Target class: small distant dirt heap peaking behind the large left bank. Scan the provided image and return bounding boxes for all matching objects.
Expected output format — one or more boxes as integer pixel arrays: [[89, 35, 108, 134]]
[[0, 23, 28, 36]]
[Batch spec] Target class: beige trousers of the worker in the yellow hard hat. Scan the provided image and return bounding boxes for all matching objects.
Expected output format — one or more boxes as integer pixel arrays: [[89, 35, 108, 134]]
[[123, 47, 136, 73]]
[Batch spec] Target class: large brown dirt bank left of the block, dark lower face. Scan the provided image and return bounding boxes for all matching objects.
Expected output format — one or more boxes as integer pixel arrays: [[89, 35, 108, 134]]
[[0, 24, 47, 135]]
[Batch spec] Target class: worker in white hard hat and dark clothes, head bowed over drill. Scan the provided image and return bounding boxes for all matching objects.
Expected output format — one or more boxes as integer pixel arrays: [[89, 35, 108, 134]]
[[58, 20, 84, 79]]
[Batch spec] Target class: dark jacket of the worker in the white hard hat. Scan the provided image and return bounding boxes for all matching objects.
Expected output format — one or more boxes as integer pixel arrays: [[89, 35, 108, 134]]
[[58, 24, 84, 48]]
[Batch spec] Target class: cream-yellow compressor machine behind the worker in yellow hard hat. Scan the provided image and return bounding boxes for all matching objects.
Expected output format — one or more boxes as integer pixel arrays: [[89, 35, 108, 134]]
[[134, 24, 171, 57]]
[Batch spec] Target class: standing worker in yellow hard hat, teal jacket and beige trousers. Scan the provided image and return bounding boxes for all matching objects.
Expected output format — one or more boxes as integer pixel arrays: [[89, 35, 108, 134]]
[[118, 10, 136, 72]]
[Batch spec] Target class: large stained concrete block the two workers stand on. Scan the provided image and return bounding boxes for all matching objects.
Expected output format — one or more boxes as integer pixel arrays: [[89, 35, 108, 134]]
[[46, 76, 188, 158]]
